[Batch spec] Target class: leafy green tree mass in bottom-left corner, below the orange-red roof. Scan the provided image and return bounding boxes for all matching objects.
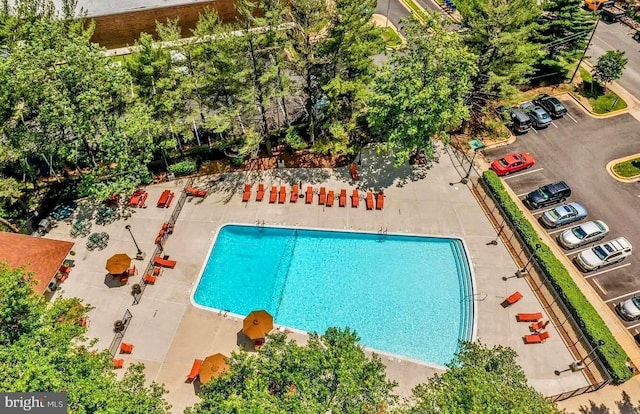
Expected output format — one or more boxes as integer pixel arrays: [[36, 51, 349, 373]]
[[0, 263, 171, 414]]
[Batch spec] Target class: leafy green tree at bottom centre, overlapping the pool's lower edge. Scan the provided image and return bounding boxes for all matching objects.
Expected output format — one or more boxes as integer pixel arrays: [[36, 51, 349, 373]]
[[186, 328, 396, 414]]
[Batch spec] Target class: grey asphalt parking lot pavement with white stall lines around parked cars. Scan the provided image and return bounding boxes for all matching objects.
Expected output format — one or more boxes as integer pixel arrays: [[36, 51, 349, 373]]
[[483, 99, 640, 334]]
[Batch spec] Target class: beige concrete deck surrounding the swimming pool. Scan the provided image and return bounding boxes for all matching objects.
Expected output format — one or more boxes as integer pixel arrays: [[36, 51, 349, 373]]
[[47, 147, 588, 412]]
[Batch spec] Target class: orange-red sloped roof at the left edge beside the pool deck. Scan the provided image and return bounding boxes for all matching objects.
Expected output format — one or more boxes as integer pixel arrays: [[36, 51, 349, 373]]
[[0, 232, 73, 294]]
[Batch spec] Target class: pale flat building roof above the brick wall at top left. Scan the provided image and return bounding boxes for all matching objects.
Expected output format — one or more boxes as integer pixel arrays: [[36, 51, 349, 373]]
[[9, 0, 208, 17]]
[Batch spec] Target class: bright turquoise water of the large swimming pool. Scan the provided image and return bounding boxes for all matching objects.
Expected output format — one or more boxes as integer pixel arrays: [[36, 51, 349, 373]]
[[193, 225, 473, 365]]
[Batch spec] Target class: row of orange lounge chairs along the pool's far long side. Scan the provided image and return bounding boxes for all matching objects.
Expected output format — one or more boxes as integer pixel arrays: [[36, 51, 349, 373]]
[[242, 183, 385, 210]]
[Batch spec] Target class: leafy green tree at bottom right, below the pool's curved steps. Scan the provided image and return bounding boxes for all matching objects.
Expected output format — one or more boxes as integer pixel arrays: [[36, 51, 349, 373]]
[[406, 342, 560, 414]]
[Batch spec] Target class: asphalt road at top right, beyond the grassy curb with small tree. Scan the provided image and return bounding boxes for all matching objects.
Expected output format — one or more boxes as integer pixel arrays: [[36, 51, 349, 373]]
[[586, 21, 640, 99]]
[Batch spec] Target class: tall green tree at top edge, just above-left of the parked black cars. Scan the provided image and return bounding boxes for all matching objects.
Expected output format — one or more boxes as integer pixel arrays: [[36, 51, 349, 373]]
[[456, 0, 543, 100]]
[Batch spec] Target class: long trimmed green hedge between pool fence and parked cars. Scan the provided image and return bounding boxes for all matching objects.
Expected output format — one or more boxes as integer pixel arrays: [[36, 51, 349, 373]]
[[482, 171, 631, 384]]
